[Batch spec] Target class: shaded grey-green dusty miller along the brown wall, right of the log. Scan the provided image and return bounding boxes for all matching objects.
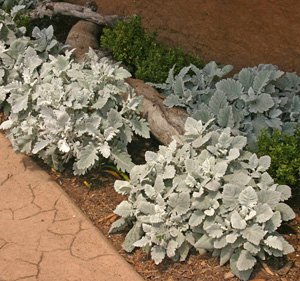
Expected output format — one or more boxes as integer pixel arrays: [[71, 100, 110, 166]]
[[149, 62, 300, 150]]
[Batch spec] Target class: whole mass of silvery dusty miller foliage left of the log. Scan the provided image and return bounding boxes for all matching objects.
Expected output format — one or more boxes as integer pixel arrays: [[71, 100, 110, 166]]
[[0, 9, 149, 174]]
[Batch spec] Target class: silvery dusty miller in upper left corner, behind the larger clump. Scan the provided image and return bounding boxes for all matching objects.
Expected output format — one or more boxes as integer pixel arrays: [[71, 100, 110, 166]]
[[0, 6, 63, 108]]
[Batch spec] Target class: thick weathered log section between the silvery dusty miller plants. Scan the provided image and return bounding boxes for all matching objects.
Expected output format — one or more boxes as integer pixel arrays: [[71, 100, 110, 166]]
[[126, 78, 189, 145]]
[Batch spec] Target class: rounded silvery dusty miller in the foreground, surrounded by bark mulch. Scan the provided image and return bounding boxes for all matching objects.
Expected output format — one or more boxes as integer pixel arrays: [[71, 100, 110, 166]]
[[110, 118, 295, 280]]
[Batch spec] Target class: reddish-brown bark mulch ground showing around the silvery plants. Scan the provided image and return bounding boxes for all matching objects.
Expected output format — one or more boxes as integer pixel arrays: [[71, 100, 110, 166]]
[[0, 3, 300, 281]]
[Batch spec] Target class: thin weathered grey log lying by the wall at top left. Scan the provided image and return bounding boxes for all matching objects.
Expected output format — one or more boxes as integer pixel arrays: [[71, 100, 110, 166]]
[[30, 2, 126, 25]]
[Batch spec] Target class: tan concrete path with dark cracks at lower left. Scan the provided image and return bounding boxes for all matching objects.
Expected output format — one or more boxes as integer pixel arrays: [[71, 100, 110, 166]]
[[0, 133, 143, 281]]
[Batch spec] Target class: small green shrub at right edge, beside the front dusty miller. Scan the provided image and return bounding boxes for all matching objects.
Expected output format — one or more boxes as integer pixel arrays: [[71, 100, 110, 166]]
[[257, 126, 300, 186]]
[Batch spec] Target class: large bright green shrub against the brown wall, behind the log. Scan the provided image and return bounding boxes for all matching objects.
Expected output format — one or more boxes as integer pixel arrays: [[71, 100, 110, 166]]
[[101, 16, 203, 83]]
